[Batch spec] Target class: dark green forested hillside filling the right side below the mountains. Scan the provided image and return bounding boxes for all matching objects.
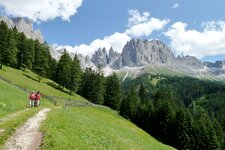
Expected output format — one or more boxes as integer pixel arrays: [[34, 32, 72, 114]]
[[120, 74, 225, 149]]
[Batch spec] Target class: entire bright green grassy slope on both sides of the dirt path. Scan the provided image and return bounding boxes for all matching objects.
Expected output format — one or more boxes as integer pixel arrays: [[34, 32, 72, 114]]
[[0, 66, 172, 149]]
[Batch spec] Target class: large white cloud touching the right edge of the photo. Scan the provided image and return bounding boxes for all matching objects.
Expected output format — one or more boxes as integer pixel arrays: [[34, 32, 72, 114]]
[[165, 21, 225, 58]]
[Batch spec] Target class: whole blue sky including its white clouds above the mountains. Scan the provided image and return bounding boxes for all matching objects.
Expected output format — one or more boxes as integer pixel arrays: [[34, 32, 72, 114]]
[[0, 0, 225, 61]]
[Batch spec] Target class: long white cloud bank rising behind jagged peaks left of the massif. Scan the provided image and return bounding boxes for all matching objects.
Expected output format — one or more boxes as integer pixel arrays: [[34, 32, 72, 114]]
[[54, 32, 130, 57]]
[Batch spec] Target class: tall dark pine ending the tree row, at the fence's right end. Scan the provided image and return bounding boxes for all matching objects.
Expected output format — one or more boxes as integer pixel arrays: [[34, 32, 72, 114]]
[[104, 73, 121, 110]]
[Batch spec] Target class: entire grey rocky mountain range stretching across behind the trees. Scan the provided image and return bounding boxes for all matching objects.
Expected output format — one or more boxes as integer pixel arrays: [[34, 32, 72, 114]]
[[0, 16, 225, 81]]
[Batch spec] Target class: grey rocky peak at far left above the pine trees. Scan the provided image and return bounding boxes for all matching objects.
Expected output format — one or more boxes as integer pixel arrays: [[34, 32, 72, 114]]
[[0, 16, 44, 43]]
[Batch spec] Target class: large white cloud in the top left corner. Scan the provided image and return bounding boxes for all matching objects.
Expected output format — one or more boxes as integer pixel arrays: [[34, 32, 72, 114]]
[[0, 0, 83, 22]]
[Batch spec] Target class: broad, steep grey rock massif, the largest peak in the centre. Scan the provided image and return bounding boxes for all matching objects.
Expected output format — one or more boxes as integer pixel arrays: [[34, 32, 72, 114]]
[[115, 39, 176, 69]]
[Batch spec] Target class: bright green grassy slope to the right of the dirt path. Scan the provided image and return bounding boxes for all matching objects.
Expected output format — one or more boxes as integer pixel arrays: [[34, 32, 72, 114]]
[[41, 107, 173, 150]]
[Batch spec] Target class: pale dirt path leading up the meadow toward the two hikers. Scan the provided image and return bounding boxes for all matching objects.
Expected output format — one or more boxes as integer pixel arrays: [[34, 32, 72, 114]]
[[4, 108, 50, 150]]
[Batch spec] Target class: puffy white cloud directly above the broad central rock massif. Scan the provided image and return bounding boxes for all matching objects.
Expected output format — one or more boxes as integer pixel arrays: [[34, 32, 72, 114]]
[[125, 10, 169, 37]]
